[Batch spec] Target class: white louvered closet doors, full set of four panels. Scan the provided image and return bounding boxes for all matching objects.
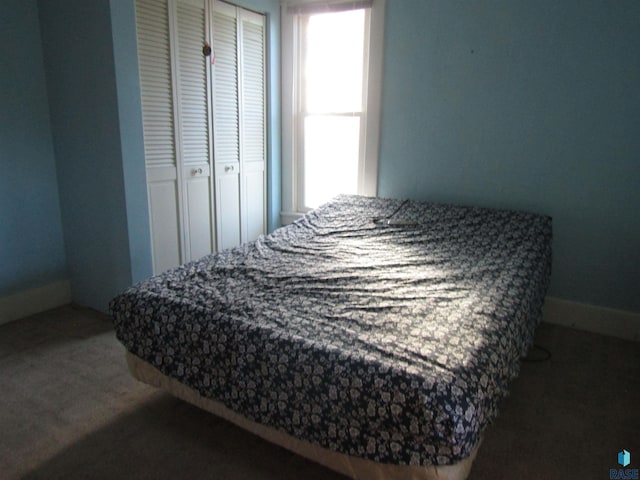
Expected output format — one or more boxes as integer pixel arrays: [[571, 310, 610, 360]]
[[136, 0, 266, 274]]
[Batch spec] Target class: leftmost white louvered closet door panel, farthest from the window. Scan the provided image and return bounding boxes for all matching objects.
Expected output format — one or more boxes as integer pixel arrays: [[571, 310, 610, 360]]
[[136, 0, 183, 273]]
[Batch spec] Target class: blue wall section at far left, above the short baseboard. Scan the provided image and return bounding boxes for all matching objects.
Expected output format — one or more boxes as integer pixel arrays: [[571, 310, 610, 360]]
[[0, 0, 67, 297]]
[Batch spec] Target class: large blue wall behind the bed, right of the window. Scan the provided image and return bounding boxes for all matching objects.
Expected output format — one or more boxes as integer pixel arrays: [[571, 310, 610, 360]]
[[378, 0, 640, 311]]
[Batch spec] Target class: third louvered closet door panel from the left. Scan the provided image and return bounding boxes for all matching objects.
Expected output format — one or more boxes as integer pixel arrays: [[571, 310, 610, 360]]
[[213, 1, 242, 250]]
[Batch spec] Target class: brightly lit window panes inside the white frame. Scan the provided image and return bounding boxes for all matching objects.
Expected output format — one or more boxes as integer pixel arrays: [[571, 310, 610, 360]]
[[301, 10, 365, 208]]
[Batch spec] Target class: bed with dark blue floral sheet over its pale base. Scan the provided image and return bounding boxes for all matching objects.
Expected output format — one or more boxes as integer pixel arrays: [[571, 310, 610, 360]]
[[110, 195, 551, 479]]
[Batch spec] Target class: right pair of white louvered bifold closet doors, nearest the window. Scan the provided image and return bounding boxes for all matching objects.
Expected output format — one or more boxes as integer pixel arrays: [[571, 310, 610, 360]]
[[213, 1, 266, 249]]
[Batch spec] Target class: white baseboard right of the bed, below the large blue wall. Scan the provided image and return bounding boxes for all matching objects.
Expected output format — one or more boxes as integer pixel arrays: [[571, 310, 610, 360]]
[[542, 297, 640, 341]]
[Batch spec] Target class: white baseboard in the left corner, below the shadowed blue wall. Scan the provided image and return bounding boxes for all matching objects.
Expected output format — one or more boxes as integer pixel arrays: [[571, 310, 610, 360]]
[[0, 280, 71, 324]]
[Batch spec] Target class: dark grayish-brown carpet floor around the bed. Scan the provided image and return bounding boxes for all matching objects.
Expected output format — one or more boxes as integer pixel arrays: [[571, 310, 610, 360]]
[[0, 306, 640, 480]]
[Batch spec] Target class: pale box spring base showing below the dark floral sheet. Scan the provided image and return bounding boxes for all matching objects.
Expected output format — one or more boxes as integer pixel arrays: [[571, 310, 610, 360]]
[[127, 352, 480, 480]]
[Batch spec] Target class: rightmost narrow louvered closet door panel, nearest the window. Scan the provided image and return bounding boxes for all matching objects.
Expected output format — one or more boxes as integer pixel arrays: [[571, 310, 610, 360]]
[[239, 9, 266, 242]]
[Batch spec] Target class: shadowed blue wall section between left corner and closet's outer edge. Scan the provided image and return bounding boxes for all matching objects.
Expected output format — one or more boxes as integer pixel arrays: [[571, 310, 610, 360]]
[[38, 0, 134, 311]]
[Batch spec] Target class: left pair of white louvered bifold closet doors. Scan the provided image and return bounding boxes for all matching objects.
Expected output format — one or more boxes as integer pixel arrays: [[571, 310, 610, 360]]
[[136, 0, 215, 273]]
